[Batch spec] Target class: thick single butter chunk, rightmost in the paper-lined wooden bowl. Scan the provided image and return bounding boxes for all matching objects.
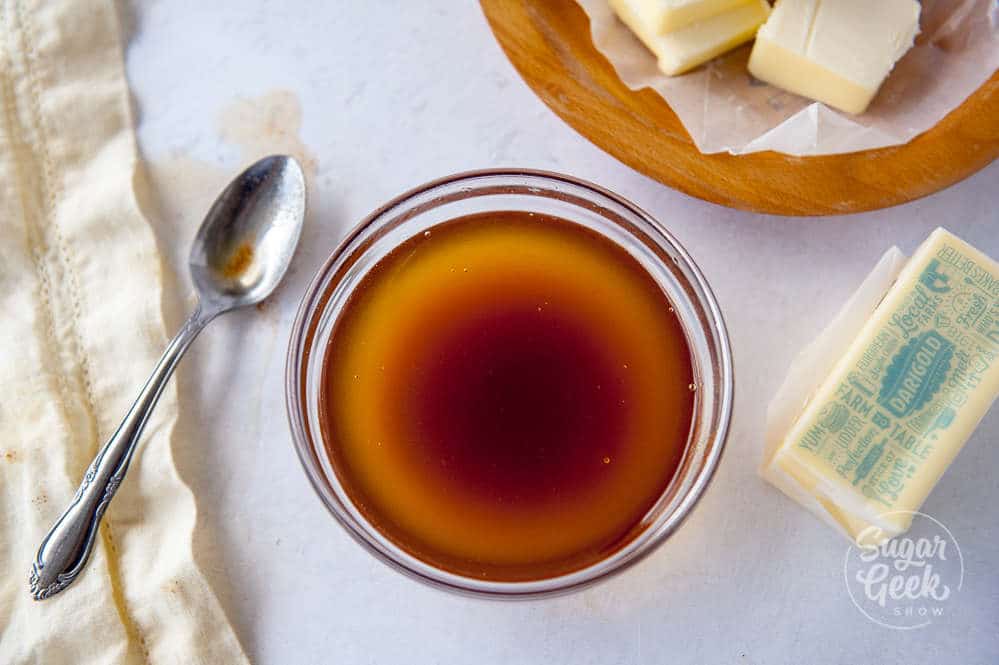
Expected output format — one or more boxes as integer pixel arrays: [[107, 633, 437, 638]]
[[749, 0, 920, 113]]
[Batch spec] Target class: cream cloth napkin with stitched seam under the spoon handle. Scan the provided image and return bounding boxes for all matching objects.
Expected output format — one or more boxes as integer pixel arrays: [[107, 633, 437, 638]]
[[0, 0, 246, 665]]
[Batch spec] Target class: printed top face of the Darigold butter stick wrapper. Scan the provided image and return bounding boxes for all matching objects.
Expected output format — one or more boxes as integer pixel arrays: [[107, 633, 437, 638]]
[[794, 236, 999, 508]]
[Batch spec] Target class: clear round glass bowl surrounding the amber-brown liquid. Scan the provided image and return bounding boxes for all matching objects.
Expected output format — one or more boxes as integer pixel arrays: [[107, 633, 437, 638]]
[[286, 169, 733, 598]]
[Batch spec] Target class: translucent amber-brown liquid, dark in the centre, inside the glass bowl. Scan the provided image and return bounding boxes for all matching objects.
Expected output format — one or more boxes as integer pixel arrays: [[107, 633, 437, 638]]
[[320, 212, 694, 581]]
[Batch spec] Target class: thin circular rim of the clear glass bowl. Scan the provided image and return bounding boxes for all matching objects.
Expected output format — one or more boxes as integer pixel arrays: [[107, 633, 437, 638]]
[[285, 168, 735, 599]]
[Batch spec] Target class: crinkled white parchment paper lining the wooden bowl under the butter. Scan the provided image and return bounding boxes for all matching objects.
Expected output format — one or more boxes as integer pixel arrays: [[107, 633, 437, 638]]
[[577, 0, 999, 155]]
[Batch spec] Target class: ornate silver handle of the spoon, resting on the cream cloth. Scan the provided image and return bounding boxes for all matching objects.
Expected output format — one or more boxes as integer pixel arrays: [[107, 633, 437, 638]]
[[29, 305, 214, 600]]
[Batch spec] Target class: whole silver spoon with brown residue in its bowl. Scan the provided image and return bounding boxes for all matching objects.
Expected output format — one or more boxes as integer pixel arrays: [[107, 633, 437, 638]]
[[29, 155, 305, 600]]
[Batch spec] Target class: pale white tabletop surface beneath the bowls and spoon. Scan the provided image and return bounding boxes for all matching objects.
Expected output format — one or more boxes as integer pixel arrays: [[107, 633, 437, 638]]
[[127, 0, 999, 665]]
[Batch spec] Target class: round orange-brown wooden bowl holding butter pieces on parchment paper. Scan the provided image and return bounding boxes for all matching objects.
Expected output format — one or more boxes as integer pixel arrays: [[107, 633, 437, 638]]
[[481, 0, 999, 215]]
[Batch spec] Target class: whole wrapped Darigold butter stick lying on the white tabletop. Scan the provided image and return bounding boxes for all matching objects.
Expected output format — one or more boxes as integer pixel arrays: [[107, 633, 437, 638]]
[[761, 229, 999, 543]]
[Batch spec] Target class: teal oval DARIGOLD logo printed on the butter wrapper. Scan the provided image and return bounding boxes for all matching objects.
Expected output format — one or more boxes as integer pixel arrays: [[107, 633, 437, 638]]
[[878, 330, 954, 418]]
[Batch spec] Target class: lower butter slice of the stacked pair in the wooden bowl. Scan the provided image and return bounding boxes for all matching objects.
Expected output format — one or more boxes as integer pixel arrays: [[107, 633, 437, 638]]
[[610, 0, 770, 76]]
